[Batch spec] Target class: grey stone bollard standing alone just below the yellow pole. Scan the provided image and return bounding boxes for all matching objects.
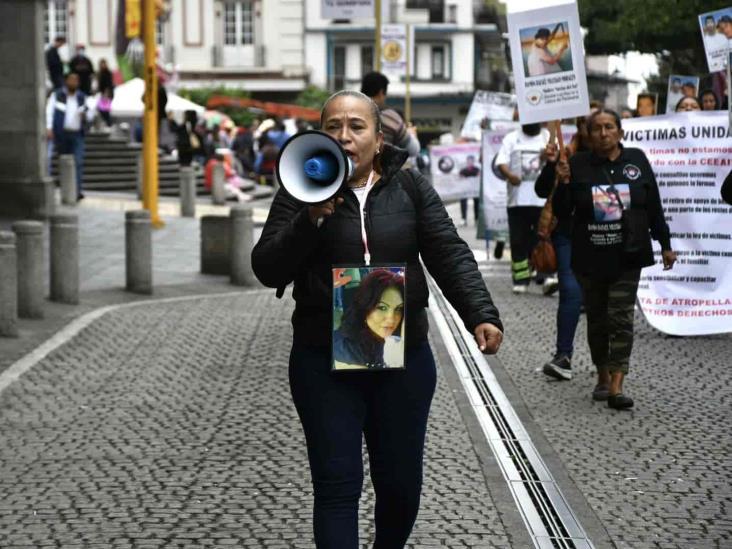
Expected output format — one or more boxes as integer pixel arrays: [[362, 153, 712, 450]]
[[125, 210, 152, 294]]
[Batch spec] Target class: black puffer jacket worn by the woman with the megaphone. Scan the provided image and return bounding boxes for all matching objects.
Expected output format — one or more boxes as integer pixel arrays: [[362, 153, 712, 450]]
[[252, 145, 503, 346]]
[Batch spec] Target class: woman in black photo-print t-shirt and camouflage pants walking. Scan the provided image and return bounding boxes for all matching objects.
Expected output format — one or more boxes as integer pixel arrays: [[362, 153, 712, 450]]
[[552, 109, 676, 410]]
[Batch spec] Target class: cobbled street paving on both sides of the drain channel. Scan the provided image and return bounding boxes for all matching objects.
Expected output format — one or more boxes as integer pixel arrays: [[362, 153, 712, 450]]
[[0, 195, 732, 549]]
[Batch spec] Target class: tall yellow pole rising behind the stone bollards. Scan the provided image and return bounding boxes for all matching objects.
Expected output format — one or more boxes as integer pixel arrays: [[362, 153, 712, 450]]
[[142, 0, 164, 228]]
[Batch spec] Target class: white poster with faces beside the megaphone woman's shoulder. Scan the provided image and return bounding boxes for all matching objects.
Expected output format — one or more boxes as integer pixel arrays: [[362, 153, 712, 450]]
[[430, 143, 480, 202]]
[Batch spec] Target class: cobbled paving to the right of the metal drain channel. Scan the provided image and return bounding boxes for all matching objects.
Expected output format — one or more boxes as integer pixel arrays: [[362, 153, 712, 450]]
[[454, 212, 732, 549]]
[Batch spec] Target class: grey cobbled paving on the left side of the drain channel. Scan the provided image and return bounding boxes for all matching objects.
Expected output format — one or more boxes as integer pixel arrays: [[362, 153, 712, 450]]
[[0, 195, 528, 549]]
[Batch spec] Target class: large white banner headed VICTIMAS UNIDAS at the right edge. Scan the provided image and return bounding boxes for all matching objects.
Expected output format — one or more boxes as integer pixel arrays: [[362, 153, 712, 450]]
[[623, 111, 732, 335]]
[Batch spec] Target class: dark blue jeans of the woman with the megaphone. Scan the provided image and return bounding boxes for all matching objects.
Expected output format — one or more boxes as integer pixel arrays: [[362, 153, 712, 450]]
[[290, 342, 436, 549]]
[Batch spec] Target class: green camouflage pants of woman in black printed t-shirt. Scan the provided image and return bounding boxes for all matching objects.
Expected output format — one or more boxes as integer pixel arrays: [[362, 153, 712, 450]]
[[577, 269, 640, 374]]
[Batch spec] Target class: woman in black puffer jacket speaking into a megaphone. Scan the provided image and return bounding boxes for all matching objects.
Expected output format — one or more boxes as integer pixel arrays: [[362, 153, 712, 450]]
[[252, 91, 503, 549]]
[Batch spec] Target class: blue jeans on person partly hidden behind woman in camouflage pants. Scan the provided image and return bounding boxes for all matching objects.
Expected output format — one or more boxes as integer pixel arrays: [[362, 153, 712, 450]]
[[552, 231, 582, 356]]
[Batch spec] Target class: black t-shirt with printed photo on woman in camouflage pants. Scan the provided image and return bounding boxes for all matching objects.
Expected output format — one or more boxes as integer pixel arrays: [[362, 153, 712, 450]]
[[553, 147, 671, 279]]
